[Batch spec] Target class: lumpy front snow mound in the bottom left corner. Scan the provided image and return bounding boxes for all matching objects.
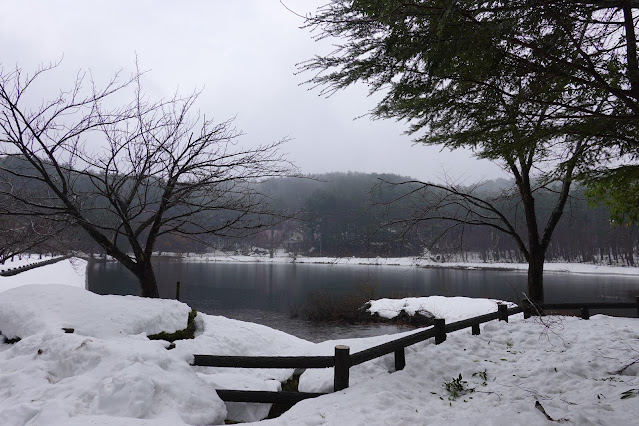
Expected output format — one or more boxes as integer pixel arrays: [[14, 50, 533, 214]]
[[0, 332, 226, 425]]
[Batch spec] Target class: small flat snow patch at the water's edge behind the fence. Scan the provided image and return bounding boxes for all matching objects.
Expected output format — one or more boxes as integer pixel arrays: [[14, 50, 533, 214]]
[[368, 296, 516, 322]]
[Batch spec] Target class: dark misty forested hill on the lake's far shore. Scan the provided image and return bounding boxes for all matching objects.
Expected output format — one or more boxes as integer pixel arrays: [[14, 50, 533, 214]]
[[257, 172, 638, 264]]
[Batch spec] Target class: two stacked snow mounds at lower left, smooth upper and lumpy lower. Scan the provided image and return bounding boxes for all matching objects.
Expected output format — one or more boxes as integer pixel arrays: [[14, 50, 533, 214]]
[[0, 284, 226, 425]]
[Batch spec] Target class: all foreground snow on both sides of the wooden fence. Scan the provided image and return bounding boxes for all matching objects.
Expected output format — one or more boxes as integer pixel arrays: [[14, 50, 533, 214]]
[[0, 262, 639, 426]]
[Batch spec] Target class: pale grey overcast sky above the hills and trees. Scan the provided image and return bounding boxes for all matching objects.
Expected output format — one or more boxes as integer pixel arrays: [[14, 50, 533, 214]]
[[0, 0, 505, 183]]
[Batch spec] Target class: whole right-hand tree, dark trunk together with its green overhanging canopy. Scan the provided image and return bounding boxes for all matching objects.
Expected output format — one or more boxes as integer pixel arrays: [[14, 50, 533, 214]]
[[301, 0, 639, 301]]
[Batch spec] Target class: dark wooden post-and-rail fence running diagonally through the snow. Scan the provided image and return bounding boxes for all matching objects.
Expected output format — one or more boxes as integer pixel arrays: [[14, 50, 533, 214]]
[[191, 304, 523, 404]]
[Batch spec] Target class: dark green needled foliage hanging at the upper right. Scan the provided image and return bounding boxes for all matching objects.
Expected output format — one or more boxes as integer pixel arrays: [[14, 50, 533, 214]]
[[302, 0, 639, 146]]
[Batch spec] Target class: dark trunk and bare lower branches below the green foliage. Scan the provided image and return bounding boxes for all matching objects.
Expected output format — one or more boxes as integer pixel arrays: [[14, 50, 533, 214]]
[[381, 130, 591, 302]]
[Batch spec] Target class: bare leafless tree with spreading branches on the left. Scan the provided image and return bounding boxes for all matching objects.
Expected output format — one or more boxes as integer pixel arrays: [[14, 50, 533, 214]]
[[0, 66, 293, 297]]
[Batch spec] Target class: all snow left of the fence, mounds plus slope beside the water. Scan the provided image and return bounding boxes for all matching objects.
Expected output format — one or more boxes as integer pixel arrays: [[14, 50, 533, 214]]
[[0, 284, 313, 425]]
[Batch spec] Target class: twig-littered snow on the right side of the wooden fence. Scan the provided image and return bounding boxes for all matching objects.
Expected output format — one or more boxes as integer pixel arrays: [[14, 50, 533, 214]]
[[260, 315, 639, 426]]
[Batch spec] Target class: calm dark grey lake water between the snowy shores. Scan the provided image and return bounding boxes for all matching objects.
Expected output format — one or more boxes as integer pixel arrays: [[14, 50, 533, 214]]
[[87, 260, 639, 341]]
